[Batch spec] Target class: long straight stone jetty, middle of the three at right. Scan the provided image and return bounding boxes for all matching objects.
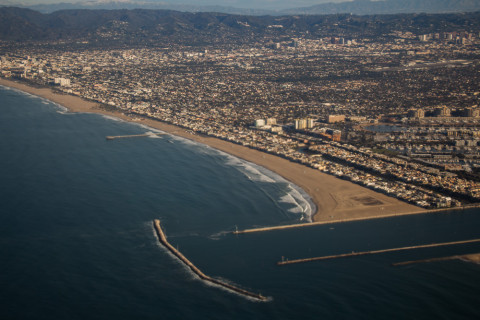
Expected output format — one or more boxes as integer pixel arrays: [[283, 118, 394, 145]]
[[277, 239, 480, 266]]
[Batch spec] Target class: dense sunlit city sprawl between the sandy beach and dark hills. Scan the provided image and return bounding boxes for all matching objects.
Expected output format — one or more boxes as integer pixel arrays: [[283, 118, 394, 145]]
[[0, 26, 480, 207]]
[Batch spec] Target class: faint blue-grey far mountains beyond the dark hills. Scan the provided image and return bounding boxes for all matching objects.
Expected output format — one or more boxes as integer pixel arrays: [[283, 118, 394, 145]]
[[0, 0, 480, 15]]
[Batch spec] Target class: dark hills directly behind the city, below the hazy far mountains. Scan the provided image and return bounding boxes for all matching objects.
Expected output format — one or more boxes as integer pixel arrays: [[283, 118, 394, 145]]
[[0, 7, 480, 45]]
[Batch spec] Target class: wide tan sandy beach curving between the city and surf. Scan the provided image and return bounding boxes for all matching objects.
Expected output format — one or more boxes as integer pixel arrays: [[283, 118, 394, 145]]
[[0, 78, 428, 222]]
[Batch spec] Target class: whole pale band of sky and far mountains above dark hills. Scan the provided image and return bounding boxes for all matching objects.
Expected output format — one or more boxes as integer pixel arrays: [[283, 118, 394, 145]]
[[0, 0, 480, 16]]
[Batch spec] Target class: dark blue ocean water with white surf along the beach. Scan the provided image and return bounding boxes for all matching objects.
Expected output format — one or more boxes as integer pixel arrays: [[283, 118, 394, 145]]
[[0, 87, 480, 320]]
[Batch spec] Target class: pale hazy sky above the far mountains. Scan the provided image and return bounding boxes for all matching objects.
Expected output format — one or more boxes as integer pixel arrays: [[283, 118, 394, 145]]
[[0, 0, 354, 9]]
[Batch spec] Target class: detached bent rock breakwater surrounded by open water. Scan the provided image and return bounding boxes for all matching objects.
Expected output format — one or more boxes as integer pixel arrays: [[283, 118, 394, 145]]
[[153, 219, 267, 301]]
